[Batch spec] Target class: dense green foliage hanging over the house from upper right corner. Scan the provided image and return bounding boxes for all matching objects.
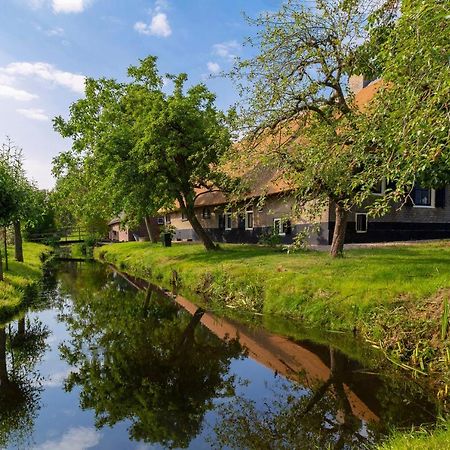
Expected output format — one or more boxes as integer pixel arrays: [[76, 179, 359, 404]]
[[355, 0, 450, 209]]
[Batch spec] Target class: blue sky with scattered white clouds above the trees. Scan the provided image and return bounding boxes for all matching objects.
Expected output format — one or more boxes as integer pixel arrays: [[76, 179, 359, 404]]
[[0, 0, 281, 189]]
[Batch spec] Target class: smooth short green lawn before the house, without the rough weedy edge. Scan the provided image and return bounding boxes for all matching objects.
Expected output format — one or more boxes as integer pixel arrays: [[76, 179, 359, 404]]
[[96, 242, 450, 329]]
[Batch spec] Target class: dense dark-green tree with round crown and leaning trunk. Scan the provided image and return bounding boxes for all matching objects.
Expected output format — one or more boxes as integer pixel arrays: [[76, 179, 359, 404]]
[[54, 56, 230, 250]]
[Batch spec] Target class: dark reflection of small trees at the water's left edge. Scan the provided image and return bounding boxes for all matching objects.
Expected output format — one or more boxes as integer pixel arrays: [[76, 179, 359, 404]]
[[0, 318, 49, 448]]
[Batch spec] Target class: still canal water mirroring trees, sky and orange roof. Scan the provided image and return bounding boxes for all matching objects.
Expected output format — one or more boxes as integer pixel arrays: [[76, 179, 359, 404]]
[[0, 263, 437, 450]]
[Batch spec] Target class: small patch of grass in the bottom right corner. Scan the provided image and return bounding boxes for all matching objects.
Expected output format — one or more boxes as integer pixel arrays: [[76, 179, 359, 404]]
[[378, 423, 450, 450]]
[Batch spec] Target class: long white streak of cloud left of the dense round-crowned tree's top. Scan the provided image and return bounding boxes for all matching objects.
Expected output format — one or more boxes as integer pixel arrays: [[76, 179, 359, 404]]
[[0, 62, 85, 94]]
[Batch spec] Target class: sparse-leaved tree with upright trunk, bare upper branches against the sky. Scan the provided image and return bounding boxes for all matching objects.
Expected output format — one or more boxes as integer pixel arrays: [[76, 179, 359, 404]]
[[230, 0, 388, 256]]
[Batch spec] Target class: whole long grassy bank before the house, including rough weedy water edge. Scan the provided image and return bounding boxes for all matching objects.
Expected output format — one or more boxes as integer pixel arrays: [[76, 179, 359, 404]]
[[95, 241, 450, 388]]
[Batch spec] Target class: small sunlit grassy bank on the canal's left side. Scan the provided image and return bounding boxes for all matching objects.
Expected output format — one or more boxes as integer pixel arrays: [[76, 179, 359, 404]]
[[0, 242, 48, 321]]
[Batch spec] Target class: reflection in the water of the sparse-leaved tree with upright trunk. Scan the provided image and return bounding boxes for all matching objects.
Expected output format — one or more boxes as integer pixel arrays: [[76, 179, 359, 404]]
[[215, 348, 372, 450]]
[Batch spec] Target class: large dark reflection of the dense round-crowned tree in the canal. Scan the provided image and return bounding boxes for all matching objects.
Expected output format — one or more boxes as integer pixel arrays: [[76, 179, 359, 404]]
[[61, 274, 242, 447]]
